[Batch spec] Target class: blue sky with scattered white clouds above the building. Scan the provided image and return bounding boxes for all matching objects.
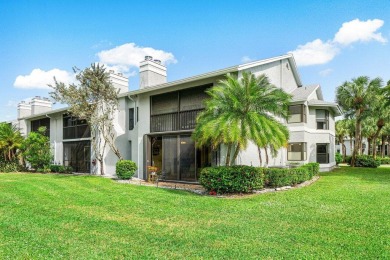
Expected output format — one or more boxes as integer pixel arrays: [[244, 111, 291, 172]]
[[0, 0, 390, 121]]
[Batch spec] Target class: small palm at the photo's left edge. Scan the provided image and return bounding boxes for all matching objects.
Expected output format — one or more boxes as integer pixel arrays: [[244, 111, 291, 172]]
[[0, 123, 23, 161]]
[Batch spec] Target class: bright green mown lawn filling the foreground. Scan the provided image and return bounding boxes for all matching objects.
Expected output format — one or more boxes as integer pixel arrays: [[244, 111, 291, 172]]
[[0, 167, 390, 259]]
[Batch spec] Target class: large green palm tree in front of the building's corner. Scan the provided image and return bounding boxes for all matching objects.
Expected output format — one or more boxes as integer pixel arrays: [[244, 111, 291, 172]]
[[193, 72, 291, 165]]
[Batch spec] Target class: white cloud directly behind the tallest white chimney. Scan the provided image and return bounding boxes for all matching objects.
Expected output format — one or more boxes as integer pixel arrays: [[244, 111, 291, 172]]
[[97, 43, 177, 75]]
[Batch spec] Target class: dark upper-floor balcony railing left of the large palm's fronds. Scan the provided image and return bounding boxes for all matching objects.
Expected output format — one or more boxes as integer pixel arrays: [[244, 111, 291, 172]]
[[150, 109, 203, 132]]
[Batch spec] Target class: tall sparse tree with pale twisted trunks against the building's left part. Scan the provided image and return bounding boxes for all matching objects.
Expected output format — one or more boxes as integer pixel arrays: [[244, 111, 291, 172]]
[[50, 64, 122, 175]]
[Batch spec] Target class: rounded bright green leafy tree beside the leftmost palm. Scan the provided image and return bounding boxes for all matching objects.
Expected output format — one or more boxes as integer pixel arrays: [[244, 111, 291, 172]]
[[22, 126, 53, 170]]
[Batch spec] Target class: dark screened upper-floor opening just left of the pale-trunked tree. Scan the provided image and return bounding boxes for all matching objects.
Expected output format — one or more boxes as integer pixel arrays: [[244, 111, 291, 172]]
[[63, 114, 91, 139]]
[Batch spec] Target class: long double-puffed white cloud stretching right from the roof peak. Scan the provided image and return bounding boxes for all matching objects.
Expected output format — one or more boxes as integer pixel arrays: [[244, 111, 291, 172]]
[[291, 19, 387, 66]]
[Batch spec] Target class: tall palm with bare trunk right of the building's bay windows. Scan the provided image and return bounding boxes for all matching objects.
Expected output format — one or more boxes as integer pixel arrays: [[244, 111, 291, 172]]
[[336, 76, 382, 167]]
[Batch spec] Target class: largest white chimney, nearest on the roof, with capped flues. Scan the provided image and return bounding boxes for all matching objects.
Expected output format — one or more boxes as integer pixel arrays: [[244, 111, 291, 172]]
[[139, 56, 167, 89]]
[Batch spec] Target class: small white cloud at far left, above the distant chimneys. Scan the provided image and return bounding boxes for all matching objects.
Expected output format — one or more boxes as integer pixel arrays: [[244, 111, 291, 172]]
[[14, 69, 74, 89]]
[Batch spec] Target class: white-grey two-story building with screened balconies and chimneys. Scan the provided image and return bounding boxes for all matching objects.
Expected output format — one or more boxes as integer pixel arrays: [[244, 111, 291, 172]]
[[18, 54, 340, 182]]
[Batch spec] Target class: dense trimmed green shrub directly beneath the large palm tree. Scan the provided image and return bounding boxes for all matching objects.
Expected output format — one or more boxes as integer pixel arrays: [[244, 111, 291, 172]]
[[199, 165, 264, 194]]
